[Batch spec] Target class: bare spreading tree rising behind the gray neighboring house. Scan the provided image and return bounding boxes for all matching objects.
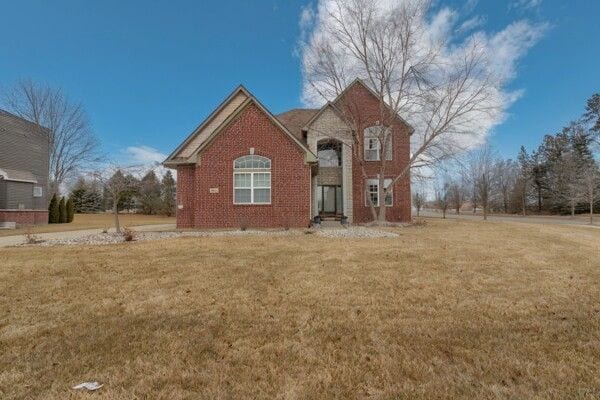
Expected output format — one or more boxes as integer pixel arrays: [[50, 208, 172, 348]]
[[2, 80, 99, 193]]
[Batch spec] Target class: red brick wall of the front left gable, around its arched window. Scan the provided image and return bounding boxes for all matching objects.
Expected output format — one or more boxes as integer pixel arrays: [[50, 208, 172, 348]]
[[177, 104, 310, 228]]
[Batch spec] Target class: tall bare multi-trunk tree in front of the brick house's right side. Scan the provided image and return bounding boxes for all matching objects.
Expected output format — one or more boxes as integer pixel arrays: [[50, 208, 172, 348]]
[[304, 0, 499, 223]]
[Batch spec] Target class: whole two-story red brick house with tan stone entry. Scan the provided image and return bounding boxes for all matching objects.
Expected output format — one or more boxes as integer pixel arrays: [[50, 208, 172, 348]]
[[164, 80, 413, 228]]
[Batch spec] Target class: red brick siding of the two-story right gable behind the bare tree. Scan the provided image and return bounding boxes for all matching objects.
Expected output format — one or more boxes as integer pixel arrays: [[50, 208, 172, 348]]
[[341, 84, 411, 223]]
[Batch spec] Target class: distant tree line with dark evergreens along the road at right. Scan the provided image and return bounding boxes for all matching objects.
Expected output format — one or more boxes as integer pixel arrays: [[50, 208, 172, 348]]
[[424, 94, 600, 223]]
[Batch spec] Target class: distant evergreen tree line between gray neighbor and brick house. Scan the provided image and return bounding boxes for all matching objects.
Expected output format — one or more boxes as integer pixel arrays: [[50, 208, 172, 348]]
[[70, 169, 176, 216]]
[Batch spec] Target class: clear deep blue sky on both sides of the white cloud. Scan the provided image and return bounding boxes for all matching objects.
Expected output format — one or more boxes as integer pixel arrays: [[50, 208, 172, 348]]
[[0, 0, 600, 166]]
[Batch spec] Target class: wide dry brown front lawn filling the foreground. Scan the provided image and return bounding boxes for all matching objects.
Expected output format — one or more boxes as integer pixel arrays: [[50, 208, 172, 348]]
[[0, 220, 600, 399]]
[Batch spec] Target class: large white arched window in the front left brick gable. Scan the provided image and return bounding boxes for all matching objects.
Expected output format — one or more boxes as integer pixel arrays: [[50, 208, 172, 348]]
[[233, 155, 271, 204]]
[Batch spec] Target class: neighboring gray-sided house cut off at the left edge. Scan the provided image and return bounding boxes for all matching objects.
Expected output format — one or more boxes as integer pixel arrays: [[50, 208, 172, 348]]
[[0, 110, 50, 225]]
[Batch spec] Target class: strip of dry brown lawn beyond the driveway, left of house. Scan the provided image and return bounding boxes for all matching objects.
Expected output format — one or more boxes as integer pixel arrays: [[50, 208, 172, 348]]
[[0, 213, 175, 237]]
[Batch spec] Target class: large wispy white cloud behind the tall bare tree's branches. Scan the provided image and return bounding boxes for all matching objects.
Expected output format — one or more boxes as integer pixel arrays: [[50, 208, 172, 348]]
[[300, 0, 548, 152]]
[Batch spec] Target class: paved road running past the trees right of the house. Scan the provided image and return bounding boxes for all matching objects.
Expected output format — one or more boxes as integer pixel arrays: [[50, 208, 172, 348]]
[[421, 210, 600, 228]]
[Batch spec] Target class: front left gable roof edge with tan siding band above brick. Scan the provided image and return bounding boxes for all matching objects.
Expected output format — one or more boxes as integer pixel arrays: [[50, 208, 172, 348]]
[[163, 85, 317, 166]]
